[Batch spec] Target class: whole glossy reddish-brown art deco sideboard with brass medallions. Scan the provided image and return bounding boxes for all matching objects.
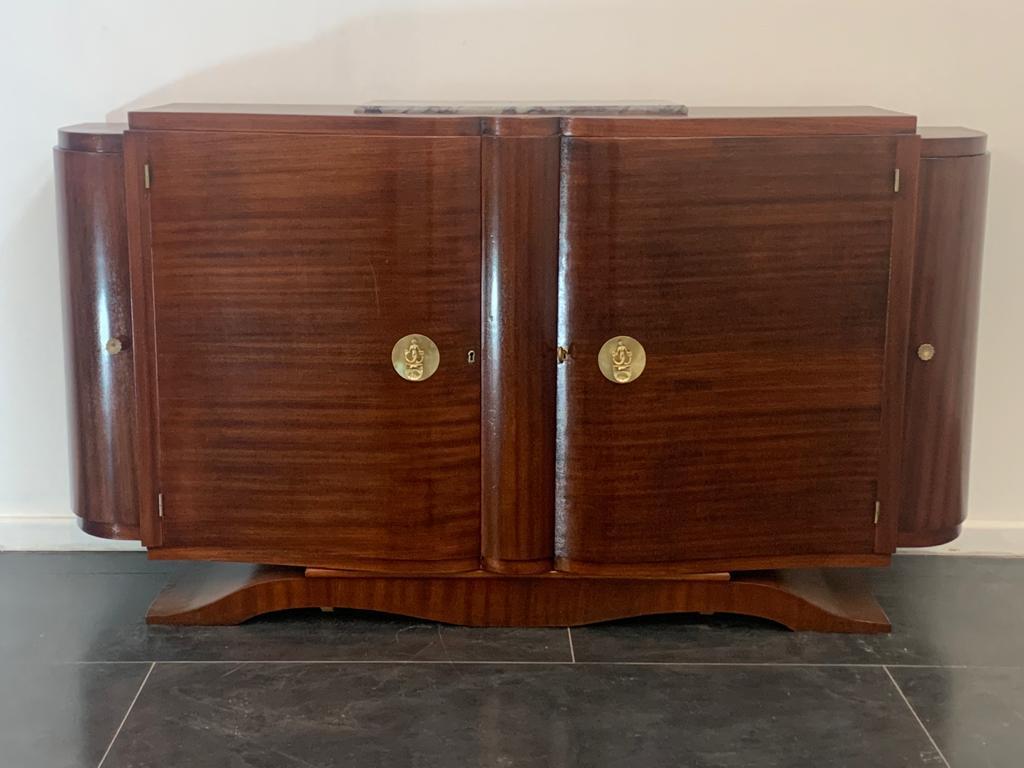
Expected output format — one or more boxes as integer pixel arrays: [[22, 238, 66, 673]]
[[55, 104, 988, 632]]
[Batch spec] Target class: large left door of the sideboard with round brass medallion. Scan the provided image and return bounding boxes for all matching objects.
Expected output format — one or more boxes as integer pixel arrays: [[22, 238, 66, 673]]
[[130, 131, 480, 570]]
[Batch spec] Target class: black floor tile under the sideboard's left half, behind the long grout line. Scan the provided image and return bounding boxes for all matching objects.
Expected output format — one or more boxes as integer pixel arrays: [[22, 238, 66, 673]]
[[0, 553, 570, 662]]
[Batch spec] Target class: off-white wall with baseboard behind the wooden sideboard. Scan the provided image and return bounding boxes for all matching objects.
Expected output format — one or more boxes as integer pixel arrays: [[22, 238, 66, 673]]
[[0, 0, 1024, 553]]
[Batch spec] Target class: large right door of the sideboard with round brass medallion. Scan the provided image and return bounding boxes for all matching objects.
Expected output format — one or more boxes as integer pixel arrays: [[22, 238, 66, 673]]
[[557, 136, 918, 572]]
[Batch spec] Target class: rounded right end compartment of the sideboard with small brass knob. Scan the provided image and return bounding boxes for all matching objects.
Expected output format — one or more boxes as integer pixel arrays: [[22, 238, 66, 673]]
[[899, 128, 988, 547]]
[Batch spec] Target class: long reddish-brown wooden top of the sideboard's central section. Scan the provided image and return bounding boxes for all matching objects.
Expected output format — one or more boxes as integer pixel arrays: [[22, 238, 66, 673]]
[[128, 102, 916, 137]]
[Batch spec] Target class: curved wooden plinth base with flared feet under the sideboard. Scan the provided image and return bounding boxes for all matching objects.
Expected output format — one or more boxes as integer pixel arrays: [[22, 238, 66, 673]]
[[146, 564, 891, 633]]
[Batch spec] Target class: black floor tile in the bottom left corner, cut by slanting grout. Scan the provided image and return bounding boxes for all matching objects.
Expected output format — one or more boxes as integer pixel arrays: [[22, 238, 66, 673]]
[[0, 660, 150, 768]]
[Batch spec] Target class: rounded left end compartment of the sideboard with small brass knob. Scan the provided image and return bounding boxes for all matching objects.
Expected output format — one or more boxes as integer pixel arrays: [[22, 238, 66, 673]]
[[53, 131, 139, 540]]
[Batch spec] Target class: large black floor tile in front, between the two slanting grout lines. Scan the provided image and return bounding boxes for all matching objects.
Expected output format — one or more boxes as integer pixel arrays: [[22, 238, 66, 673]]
[[104, 664, 940, 768]]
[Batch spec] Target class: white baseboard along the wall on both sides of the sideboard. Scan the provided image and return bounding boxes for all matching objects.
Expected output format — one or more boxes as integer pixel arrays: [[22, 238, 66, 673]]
[[0, 514, 1024, 557]]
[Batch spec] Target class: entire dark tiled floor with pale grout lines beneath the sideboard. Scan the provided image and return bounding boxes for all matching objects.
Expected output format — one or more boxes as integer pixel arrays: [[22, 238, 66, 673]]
[[0, 553, 1024, 768]]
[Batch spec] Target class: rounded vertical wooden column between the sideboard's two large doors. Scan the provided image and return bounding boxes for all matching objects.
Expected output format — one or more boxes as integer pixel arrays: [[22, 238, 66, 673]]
[[480, 129, 560, 573]]
